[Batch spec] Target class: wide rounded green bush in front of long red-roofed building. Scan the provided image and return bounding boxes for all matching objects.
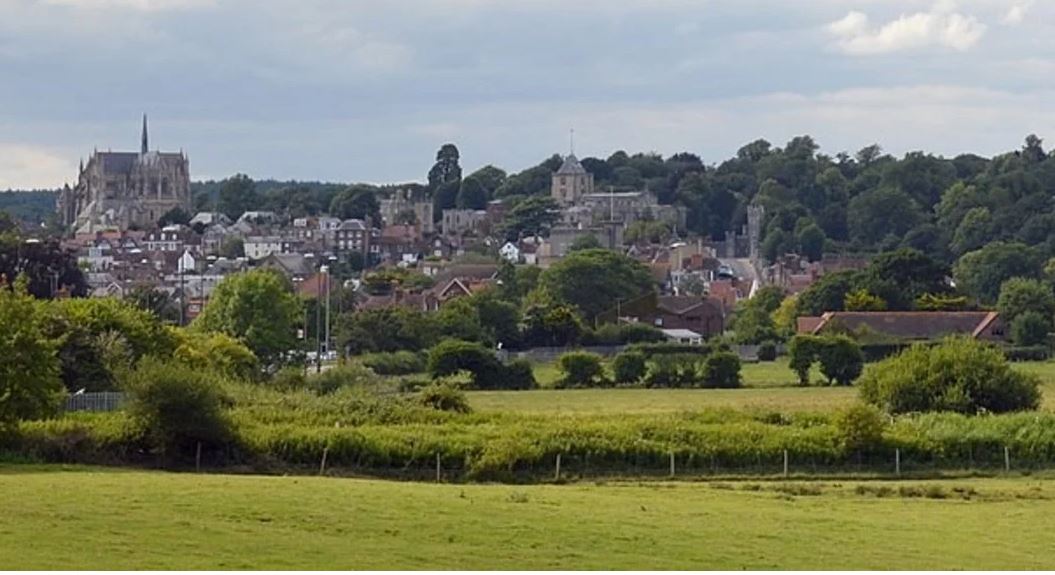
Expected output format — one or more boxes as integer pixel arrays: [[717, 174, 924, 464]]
[[860, 339, 1040, 414]]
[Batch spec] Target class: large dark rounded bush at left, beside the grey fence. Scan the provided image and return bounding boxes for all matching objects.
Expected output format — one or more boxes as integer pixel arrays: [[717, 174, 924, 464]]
[[124, 357, 231, 458]]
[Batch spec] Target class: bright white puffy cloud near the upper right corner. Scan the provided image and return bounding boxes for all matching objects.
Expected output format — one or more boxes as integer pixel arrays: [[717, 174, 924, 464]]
[[826, 1, 987, 56]]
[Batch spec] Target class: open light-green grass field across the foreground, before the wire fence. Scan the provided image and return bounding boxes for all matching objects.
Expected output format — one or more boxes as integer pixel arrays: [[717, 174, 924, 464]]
[[0, 466, 1055, 570]]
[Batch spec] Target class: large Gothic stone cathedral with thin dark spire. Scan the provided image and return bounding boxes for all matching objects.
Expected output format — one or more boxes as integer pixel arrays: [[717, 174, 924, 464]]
[[58, 116, 191, 233]]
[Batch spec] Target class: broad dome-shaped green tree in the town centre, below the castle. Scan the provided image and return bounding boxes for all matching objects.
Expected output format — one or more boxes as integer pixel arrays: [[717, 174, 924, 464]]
[[539, 249, 655, 321]]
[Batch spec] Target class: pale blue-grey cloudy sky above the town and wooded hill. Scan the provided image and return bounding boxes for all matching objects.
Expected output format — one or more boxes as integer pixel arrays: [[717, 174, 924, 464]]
[[0, 0, 1055, 189]]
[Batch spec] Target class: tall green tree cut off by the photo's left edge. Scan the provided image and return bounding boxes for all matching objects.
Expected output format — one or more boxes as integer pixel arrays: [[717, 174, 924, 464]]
[[0, 277, 63, 432]]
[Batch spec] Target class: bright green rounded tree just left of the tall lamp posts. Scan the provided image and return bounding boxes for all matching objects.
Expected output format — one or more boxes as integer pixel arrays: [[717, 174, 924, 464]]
[[192, 269, 303, 366]]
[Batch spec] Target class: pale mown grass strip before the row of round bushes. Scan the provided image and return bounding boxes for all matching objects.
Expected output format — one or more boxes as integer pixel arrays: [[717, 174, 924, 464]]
[[487, 359, 1055, 414]]
